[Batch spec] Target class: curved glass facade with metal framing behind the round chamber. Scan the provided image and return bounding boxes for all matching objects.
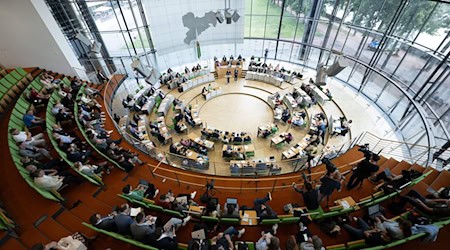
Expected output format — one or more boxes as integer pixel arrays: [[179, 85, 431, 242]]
[[47, 0, 450, 163]]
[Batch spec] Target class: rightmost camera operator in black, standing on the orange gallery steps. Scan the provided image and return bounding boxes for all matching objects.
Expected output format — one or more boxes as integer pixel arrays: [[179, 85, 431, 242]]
[[347, 144, 380, 190]]
